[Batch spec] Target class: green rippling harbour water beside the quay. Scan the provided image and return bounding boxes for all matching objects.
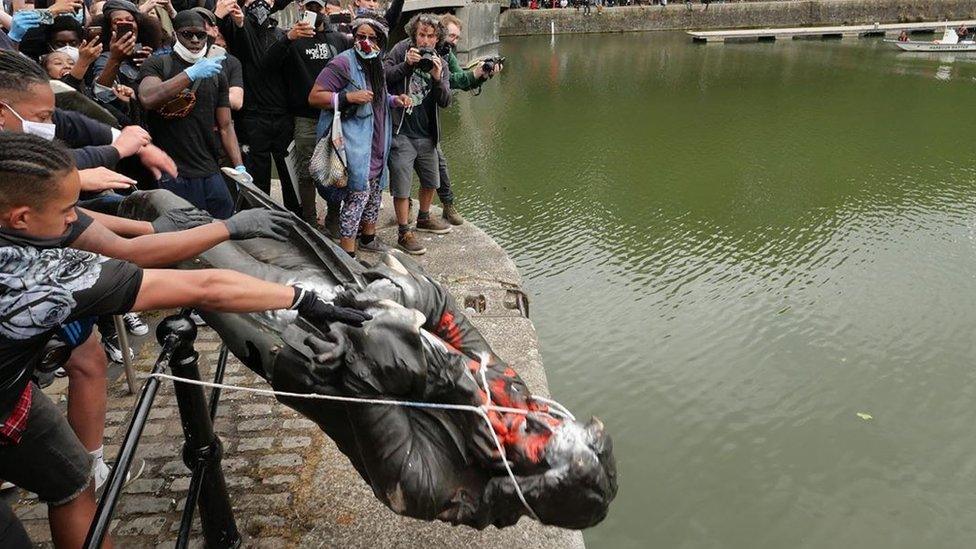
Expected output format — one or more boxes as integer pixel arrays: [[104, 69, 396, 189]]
[[444, 33, 976, 549]]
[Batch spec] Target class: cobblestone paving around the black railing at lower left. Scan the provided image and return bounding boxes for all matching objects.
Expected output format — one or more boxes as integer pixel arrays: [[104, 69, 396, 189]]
[[14, 315, 324, 547]]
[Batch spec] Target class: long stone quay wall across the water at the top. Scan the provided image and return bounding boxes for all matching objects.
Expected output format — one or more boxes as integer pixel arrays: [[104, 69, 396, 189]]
[[499, 0, 976, 36]]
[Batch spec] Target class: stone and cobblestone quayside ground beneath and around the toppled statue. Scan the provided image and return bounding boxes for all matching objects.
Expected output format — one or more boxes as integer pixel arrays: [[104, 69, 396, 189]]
[[15, 205, 582, 549]]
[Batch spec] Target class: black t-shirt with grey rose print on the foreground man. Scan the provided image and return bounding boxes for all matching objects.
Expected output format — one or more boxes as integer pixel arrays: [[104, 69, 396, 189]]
[[0, 225, 142, 418]]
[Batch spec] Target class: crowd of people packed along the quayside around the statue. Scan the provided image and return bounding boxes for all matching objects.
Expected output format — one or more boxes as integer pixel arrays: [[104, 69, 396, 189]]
[[0, 0, 503, 547]]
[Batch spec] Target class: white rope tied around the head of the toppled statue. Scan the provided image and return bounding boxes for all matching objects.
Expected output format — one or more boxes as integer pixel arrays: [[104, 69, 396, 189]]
[[149, 354, 556, 520]]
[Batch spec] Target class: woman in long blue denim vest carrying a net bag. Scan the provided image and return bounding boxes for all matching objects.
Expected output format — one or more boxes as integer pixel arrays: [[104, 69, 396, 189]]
[[308, 11, 410, 257]]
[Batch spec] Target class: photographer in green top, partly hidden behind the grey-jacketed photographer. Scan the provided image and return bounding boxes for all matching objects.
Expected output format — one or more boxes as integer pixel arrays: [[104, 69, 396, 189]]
[[437, 14, 502, 225]]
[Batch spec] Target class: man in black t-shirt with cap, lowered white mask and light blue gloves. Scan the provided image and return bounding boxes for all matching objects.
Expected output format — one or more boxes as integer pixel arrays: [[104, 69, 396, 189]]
[[140, 9, 247, 219]]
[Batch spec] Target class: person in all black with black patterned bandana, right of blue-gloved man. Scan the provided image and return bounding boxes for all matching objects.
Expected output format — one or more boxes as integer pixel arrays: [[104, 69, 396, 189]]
[[214, 0, 302, 215]]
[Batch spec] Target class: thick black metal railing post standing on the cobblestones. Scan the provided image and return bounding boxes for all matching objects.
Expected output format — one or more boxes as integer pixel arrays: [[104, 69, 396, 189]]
[[167, 314, 241, 547]]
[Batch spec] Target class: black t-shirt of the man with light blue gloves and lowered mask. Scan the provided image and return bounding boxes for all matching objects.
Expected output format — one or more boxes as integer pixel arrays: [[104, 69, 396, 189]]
[[139, 54, 230, 177]]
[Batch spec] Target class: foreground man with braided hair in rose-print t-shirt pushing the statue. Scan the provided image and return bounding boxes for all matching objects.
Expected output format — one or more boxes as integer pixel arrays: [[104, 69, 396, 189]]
[[0, 132, 371, 547]]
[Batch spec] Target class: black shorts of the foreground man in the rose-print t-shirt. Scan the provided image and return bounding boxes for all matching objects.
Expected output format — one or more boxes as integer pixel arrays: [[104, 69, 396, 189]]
[[0, 385, 92, 505]]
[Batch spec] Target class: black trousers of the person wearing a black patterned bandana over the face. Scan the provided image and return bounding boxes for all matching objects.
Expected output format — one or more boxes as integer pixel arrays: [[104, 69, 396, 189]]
[[235, 113, 302, 216]]
